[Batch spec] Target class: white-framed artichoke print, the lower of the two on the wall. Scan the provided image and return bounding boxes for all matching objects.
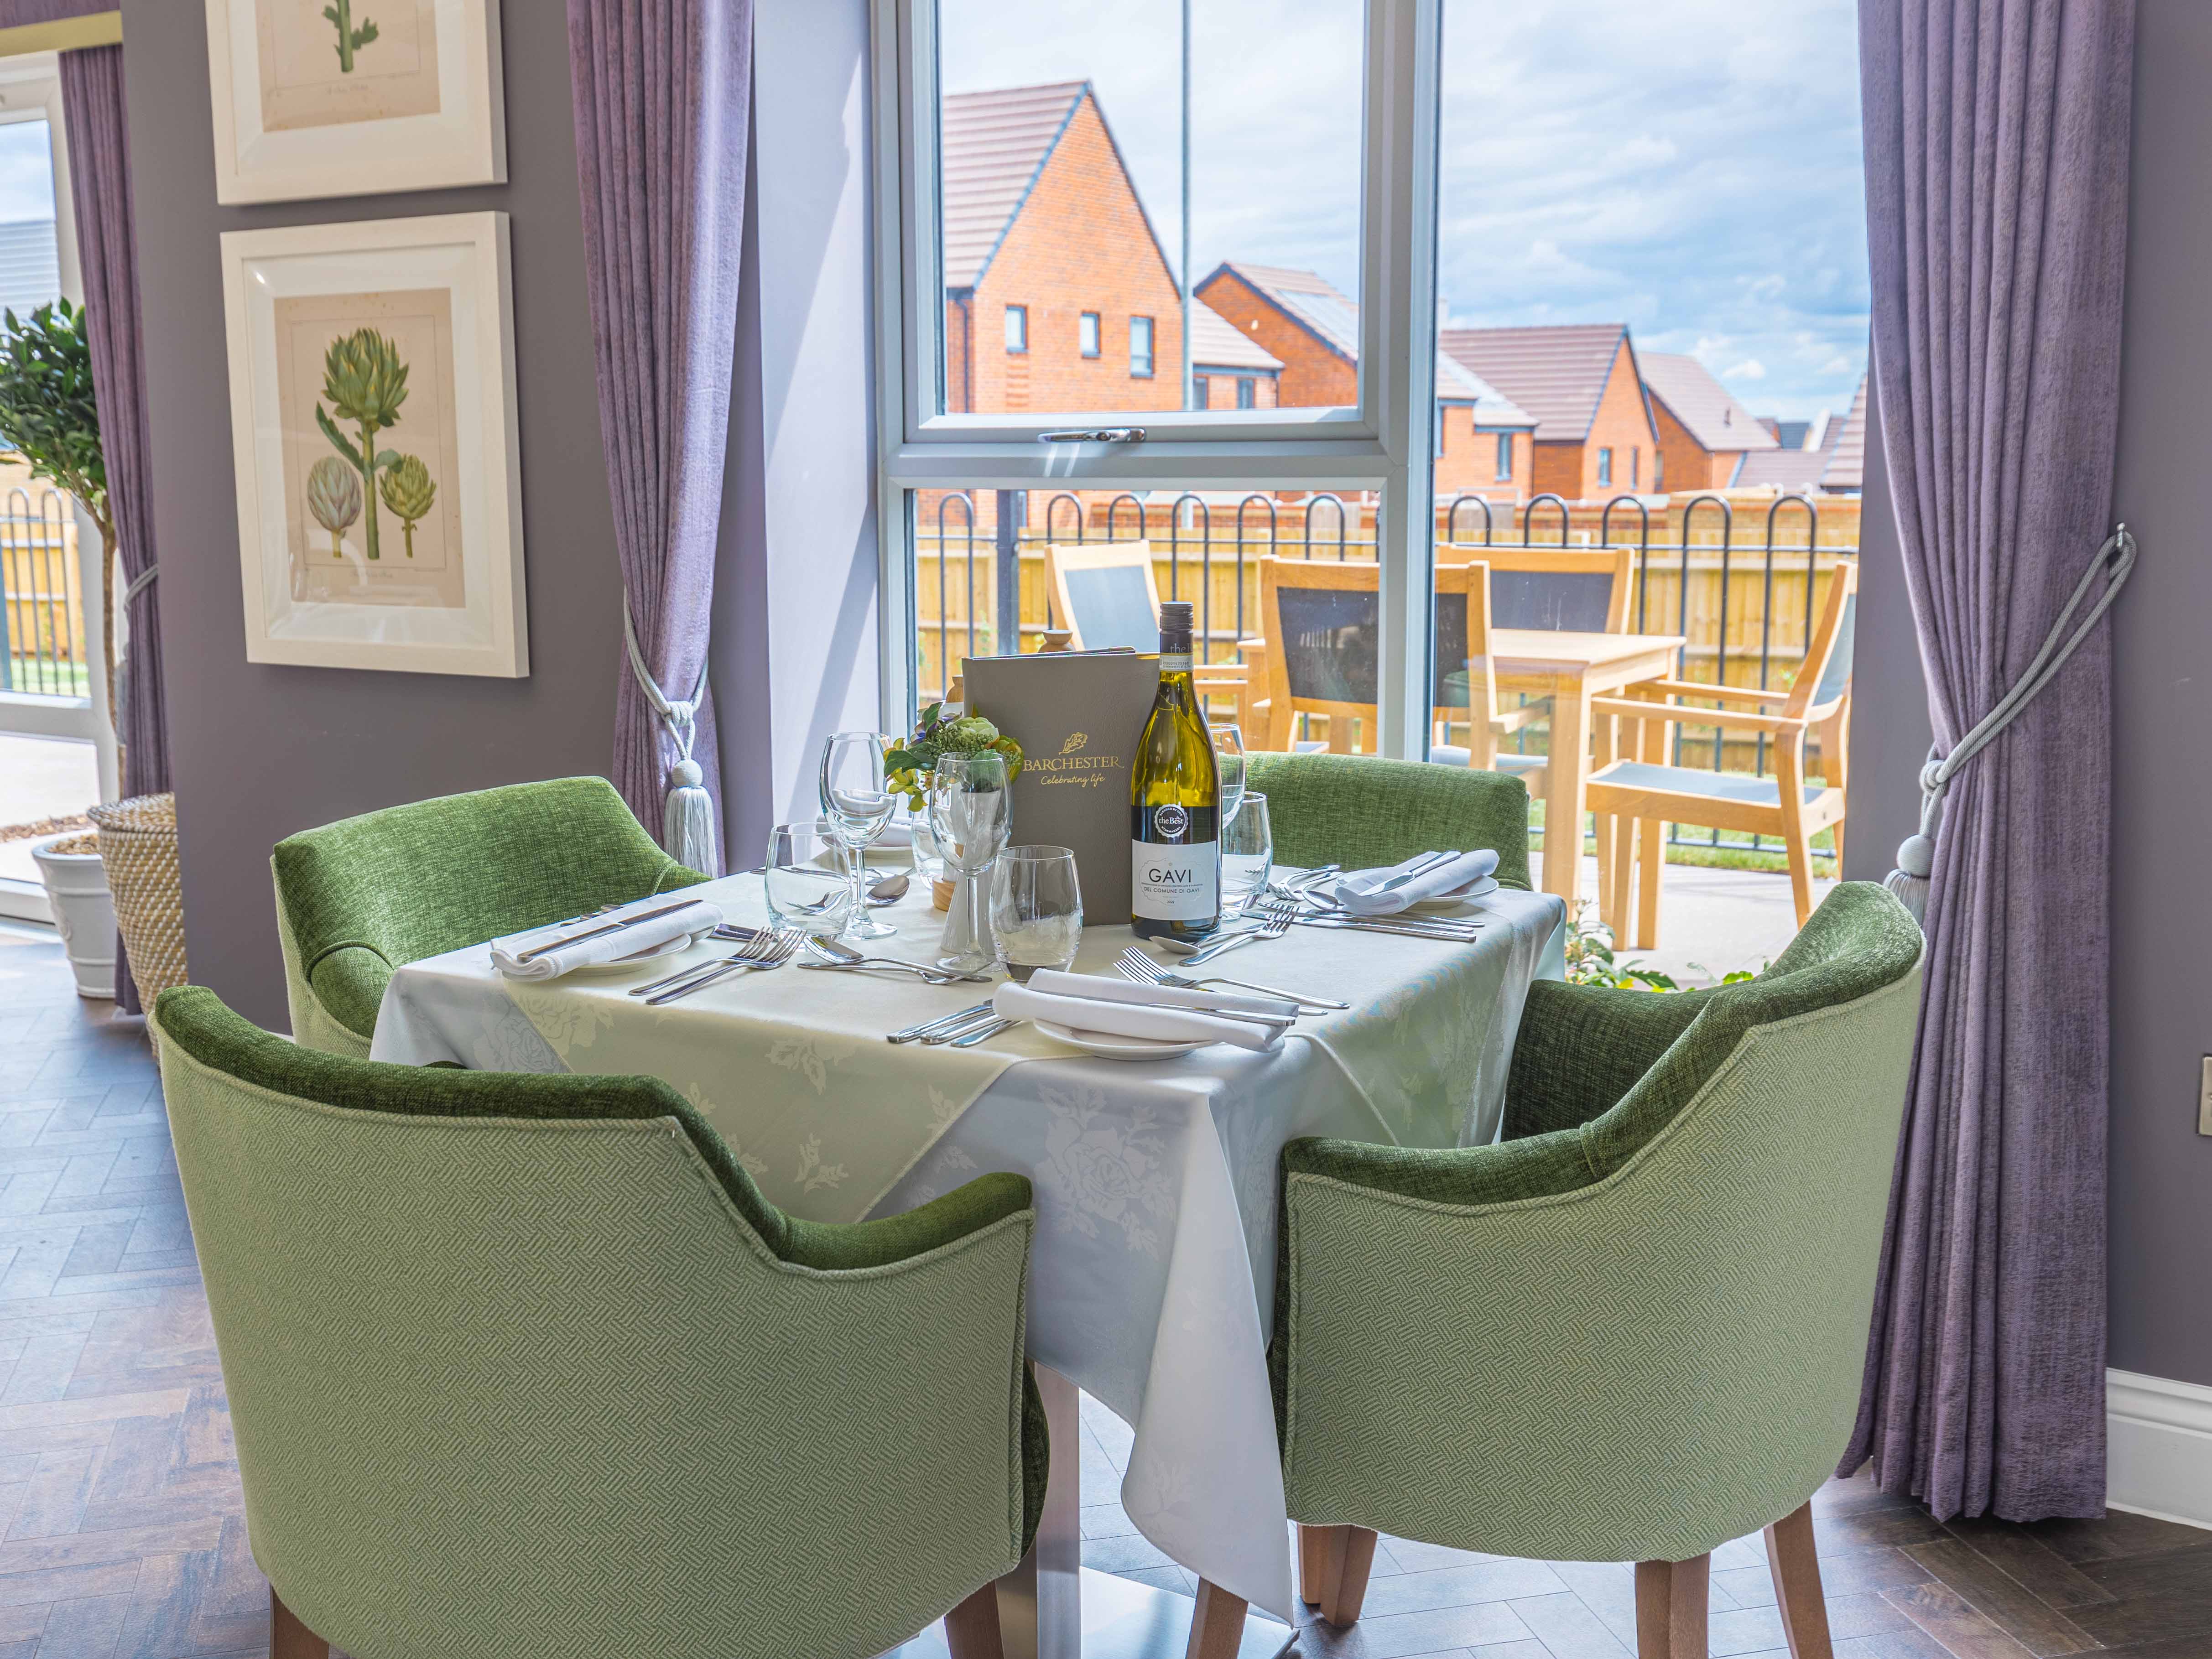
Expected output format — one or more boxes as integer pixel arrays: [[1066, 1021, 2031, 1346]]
[[224, 213, 529, 679]]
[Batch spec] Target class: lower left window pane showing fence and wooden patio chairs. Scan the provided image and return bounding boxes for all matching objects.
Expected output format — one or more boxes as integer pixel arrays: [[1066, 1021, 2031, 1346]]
[[907, 489, 1378, 752]]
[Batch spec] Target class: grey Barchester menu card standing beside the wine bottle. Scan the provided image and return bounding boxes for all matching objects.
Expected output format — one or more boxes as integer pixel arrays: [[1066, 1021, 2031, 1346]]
[[962, 650, 1159, 927]]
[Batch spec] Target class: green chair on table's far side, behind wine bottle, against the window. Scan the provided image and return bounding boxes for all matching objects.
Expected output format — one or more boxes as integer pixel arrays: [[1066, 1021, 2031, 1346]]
[[1245, 754, 1529, 891]]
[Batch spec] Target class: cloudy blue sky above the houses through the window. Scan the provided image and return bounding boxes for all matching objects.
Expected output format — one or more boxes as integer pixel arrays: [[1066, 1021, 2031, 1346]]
[[940, 0, 1867, 418]]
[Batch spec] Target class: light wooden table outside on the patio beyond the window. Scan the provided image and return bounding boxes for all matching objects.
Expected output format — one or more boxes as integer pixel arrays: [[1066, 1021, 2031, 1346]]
[[1491, 628, 1686, 905]]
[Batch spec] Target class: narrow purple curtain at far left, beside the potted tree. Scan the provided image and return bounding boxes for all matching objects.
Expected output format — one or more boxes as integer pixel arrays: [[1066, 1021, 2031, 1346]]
[[62, 47, 168, 1013]]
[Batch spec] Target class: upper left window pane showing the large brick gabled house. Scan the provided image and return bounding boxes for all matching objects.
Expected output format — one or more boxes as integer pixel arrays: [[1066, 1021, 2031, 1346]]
[[938, 0, 1365, 414]]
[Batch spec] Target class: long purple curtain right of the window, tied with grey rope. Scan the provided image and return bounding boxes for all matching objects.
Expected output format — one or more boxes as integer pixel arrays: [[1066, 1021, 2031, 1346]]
[[1845, 0, 2134, 1519]]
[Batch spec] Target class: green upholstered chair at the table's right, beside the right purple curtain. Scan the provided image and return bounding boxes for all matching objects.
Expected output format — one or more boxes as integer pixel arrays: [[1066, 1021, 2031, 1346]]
[[1270, 883, 1920, 1659]]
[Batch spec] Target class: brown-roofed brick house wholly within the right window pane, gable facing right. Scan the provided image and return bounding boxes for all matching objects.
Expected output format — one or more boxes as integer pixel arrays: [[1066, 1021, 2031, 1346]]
[[1438, 323, 1663, 502]]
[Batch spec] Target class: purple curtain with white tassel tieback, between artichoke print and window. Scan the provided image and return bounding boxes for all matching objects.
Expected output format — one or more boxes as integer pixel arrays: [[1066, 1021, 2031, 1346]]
[[568, 0, 752, 874]]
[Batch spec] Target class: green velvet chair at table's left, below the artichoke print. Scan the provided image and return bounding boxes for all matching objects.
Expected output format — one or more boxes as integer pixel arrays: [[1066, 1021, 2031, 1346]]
[[270, 779, 706, 1060]]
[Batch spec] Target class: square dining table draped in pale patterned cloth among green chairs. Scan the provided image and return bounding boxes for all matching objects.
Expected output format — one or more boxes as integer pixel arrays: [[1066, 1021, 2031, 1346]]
[[372, 871, 1575, 1659]]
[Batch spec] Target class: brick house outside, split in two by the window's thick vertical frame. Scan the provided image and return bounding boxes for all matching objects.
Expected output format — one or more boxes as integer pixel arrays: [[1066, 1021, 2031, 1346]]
[[1197, 261, 1535, 500]]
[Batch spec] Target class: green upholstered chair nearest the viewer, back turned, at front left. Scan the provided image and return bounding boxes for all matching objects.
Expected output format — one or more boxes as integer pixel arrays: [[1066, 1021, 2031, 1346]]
[[155, 989, 1048, 1659]]
